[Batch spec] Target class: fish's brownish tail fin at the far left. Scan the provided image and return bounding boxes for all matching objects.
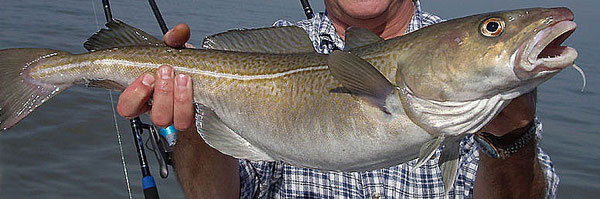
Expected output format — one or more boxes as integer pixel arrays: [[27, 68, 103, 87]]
[[0, 48, 67, 131]]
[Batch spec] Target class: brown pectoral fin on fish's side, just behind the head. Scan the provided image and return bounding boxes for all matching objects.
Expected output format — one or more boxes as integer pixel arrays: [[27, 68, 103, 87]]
[[328, 51, 396, 113]]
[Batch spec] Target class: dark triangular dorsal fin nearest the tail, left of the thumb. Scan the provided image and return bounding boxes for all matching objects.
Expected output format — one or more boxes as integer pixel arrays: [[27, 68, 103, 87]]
[[83, 19, 165, 52]]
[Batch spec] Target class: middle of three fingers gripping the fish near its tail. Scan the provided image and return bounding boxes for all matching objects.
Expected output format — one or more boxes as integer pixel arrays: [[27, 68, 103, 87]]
[[150, 65, 174, 127]]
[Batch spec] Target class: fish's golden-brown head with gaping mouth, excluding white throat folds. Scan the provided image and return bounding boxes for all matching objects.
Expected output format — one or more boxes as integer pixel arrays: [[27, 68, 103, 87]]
[[396, 8, 577, 101]]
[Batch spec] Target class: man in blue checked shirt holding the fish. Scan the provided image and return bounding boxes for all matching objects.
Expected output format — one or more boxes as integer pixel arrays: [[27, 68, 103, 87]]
[[118, 0, 558, 198]]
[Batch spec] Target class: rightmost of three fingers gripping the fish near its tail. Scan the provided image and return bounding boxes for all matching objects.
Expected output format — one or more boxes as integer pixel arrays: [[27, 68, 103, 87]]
[[173, 74, 194, 131]]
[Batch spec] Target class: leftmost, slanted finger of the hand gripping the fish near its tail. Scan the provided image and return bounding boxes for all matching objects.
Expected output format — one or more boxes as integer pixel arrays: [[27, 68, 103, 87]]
[[117, 74, 155, 118]]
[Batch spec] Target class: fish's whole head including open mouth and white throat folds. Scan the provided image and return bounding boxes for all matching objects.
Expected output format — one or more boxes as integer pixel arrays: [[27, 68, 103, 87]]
[[396, 8, 577, 135]]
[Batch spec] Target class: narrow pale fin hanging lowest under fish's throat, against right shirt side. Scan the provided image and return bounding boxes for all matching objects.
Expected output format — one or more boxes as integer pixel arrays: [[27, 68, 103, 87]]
[[438, 137, 462, 194]]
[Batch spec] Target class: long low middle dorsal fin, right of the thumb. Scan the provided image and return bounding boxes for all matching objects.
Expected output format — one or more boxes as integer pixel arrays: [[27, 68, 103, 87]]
[[202, 26, 315, 54]]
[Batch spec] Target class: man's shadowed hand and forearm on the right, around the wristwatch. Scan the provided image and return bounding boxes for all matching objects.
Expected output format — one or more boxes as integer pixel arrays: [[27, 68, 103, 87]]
[[473, 90, 546, 198]]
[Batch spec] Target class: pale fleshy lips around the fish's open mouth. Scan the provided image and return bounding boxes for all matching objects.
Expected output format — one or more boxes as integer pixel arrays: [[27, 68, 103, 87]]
[[514, 15, 577, 79]]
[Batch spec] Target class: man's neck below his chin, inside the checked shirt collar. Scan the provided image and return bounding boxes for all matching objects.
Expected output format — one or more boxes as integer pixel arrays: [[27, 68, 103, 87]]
[[329, 0, 415, 39]]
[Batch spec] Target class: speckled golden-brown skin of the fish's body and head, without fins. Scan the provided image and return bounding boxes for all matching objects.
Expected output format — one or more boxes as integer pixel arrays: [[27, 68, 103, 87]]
[[0, 8, 574, 171]]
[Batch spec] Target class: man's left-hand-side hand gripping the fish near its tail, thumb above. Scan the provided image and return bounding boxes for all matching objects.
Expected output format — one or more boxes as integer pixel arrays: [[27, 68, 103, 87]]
[[117, 24, 194, 130]]
